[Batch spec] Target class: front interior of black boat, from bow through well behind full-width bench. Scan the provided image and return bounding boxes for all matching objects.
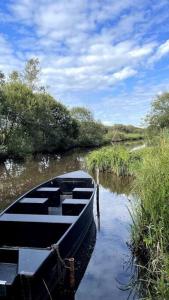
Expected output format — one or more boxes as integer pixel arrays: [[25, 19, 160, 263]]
[[0, 172, 94, 248]]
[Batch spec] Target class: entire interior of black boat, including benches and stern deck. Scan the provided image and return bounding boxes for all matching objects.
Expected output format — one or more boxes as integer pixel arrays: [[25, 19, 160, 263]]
[[0, 172, 95, 286]]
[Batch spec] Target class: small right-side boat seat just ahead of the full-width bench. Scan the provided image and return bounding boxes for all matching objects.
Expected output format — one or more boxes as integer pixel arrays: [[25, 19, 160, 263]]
[[62, 199, 89, 216]]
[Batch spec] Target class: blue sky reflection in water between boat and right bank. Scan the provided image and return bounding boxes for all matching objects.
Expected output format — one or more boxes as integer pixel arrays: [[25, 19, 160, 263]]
[[75, 187, 137, 300]]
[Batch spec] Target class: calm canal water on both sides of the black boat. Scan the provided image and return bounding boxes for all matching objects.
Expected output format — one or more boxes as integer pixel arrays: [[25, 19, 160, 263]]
[[0, 150, 139, 300]]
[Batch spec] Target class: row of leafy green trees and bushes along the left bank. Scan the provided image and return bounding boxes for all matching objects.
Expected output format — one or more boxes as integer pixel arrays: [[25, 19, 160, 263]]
[[0, 59, 105, 158]]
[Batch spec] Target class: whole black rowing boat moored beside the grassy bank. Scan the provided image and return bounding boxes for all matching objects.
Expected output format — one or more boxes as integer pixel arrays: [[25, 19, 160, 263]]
[[0, 171, 96, 300]]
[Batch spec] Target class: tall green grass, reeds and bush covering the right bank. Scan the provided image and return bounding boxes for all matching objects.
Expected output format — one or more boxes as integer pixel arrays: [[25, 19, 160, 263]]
[[86, 93, 169, 300]]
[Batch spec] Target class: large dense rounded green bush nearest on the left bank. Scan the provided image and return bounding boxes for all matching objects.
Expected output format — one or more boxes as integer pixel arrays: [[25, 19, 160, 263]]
[[0, 66, 78, 157]]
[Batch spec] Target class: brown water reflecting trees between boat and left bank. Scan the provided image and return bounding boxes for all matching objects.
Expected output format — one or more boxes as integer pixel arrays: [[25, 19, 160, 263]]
[[0, 150, 87, 210]]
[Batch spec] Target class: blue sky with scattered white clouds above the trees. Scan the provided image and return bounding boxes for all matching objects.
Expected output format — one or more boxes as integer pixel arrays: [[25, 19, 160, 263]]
[[0, 0, 169, 126]]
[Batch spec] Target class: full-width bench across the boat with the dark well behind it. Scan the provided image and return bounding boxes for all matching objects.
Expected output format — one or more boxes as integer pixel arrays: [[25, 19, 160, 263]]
[[0, 213, 77, 249]]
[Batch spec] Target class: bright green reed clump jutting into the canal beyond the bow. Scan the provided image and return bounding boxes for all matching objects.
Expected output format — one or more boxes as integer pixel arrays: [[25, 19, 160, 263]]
[[86, 146, 142, 176]]
